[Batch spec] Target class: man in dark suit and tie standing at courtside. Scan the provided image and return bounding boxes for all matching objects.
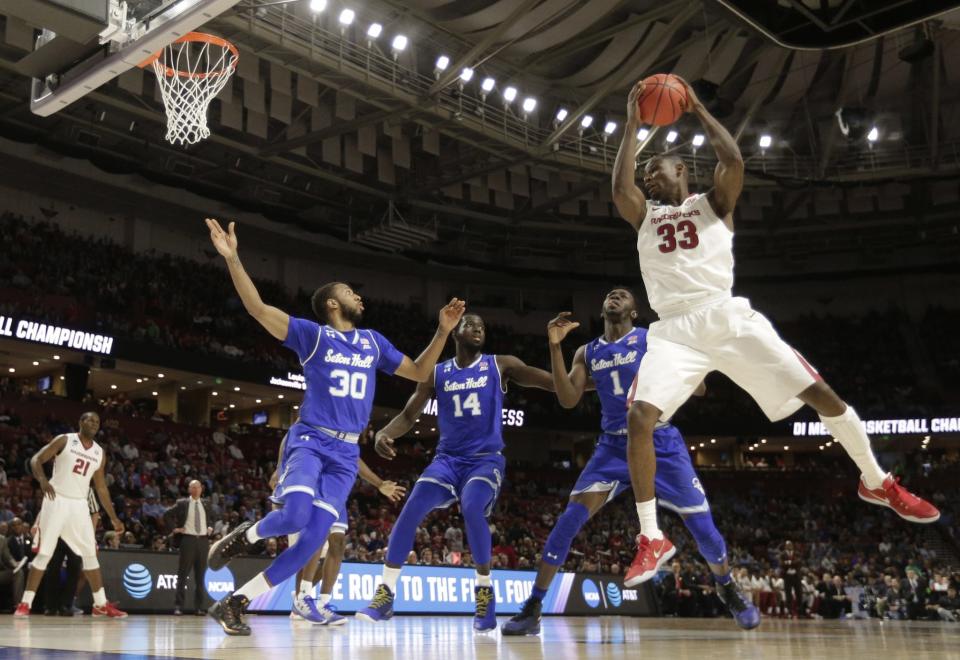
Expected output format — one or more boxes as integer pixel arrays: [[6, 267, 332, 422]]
[[163, 479, 213, 616]]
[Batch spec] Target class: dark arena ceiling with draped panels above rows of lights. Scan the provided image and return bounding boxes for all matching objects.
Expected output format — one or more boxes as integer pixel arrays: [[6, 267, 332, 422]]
[[0, 0, 960, 272]]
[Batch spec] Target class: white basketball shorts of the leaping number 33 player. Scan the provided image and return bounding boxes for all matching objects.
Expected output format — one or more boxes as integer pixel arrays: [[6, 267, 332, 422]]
[[627, 298, 820, 421]]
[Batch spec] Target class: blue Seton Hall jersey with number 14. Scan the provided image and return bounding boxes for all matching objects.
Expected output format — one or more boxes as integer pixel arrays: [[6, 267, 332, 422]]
[[433, 355, 506, 457]]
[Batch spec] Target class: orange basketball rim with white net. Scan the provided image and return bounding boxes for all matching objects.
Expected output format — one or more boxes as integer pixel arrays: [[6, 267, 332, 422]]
[[140, 32, 240, 144]]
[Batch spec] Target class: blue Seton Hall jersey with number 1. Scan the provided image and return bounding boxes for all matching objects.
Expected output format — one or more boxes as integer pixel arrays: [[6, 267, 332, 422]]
[[584, 328, 647, 437]]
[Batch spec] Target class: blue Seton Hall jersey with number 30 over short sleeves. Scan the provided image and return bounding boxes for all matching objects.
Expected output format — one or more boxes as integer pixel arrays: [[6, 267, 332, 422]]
[[283, 316, 403, 433]]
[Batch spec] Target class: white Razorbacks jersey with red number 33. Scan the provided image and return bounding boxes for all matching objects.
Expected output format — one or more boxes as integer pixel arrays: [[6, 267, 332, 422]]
[[637, 195, 733, 318]]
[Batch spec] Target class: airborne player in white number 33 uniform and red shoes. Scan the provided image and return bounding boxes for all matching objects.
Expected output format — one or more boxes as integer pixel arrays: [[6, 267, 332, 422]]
[[613, 75, 940, 586]]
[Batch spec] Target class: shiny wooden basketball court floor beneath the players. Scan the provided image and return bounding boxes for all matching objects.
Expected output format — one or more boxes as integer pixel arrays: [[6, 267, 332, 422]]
[[0, 615, 960, 660]]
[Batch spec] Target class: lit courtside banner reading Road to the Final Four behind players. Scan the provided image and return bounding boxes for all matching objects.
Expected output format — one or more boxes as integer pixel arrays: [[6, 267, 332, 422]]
[[94, 550, 658, 616]]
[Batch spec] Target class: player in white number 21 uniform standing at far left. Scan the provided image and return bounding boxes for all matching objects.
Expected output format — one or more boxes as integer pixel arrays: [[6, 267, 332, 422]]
[[14, 412, 127, 619]]
